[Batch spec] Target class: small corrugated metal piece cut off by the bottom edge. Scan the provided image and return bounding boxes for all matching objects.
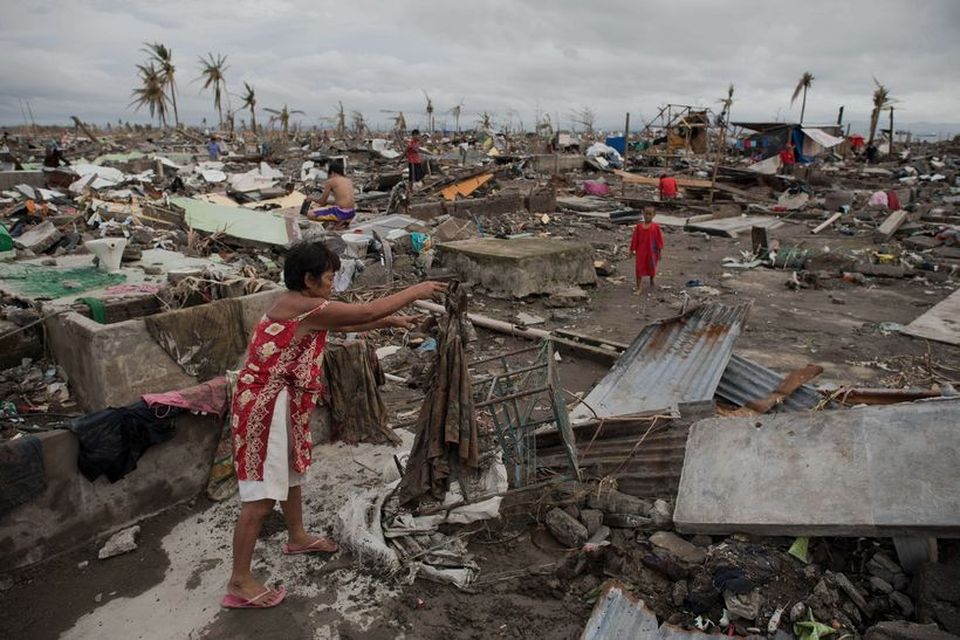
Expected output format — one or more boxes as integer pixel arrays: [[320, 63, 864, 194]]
[[580, 580, 659, 640]]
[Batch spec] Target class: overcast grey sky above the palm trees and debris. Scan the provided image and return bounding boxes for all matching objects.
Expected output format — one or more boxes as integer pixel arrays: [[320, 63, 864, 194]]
[[0, 0, 960, 133]]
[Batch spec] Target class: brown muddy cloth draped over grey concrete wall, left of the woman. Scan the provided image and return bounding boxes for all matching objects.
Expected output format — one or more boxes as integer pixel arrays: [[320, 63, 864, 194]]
[[144, 299, 250, 381]]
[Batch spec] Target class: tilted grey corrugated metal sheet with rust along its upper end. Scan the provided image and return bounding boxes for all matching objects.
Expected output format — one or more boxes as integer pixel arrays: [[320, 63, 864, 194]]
[[571, 303, 750, 422]]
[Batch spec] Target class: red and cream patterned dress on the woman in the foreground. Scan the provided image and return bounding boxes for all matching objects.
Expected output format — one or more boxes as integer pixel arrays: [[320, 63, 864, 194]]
[[231, 300, 328, 480]]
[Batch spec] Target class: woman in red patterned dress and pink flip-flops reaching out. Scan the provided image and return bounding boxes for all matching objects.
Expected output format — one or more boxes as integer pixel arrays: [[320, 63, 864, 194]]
[[221, 241, 446, 609]]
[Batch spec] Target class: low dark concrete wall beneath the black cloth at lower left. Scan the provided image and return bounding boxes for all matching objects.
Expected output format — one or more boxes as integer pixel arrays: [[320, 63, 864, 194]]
[[0, 414, 221, 569]]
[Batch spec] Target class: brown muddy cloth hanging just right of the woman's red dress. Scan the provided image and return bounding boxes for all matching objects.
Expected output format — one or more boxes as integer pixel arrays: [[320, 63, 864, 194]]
[[323, 340, 400, 445]]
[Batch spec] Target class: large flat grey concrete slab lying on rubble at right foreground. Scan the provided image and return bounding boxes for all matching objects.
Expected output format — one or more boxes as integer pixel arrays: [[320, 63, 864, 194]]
[[673, 400, 960, 537]]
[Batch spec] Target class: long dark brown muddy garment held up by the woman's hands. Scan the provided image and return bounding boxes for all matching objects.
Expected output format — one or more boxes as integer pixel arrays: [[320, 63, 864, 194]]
[[398, 282, 480, 505]]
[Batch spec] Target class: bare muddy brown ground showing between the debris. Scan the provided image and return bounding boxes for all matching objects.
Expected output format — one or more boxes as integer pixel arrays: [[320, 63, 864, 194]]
[[0, 214, 960, 640]]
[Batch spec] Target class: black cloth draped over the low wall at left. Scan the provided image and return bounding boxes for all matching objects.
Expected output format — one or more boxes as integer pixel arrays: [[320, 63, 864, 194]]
[[65, 400, 180, 482]]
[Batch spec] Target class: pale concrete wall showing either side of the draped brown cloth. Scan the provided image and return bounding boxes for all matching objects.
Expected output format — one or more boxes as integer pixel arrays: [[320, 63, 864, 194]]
[[45, 289, 283, 412]]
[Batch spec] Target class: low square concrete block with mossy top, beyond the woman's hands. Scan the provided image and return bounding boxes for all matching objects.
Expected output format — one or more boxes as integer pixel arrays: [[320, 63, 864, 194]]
[[438, 238, 597, 298]]
